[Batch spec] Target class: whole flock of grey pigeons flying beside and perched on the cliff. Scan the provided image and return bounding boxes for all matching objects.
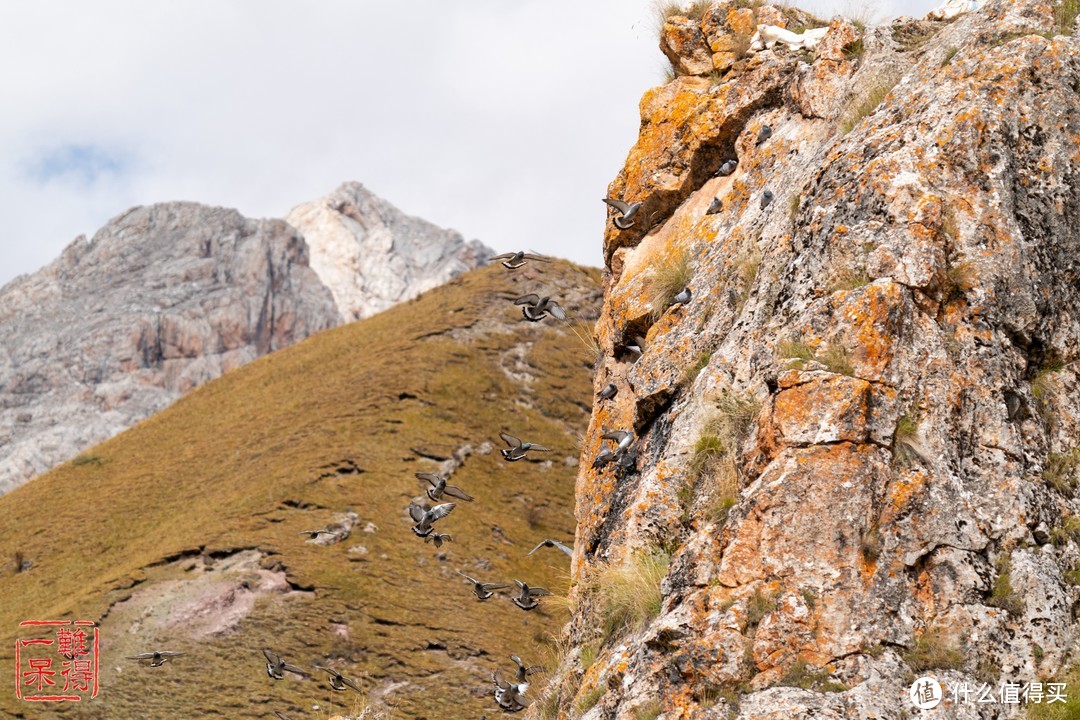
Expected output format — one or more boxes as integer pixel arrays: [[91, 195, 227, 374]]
[[118, 140, 774, 720]]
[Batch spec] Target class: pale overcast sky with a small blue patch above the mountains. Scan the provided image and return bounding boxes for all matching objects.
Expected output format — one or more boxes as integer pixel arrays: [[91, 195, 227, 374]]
[[0, 0, 940, 284]]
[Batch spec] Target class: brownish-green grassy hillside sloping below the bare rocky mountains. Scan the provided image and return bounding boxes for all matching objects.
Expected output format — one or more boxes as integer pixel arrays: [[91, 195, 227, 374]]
[[0, 263, 599, 719]]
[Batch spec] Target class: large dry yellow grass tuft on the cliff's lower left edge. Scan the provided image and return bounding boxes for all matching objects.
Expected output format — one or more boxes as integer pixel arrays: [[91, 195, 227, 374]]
[[590, 549, 671, 638]]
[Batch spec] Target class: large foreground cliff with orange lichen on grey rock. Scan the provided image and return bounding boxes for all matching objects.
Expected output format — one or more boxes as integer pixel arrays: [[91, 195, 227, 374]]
[[540, 0, 1080, 720]]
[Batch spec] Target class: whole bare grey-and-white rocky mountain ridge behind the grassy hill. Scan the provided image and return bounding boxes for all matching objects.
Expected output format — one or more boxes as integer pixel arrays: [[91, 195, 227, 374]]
[[0, 184, 490, 492]]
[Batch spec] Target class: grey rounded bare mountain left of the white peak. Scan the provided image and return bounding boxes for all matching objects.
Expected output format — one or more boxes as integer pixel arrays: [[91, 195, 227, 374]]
[[0, 203, 338, 491]]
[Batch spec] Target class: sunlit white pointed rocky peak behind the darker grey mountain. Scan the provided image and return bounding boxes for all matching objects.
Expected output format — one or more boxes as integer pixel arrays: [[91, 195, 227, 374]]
[[285, 182, 494, 323]]
